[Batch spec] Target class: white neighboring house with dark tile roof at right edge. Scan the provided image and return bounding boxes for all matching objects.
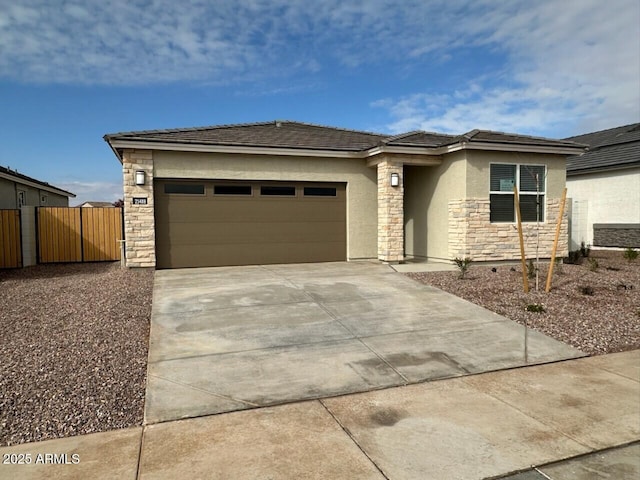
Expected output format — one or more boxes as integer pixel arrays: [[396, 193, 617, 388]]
[[566, 123, 640, 249]]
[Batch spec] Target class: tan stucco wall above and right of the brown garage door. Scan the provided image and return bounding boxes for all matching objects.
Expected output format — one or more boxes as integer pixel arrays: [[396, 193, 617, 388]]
[[153, 151, 378, 260]]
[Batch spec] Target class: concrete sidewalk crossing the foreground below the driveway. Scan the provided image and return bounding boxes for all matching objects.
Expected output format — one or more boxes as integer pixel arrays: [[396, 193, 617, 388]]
[[0, 350, 640, 480]]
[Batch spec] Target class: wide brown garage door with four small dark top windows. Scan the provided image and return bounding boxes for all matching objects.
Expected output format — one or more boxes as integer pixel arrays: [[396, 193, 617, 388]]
[[154, 179, 347, 268]]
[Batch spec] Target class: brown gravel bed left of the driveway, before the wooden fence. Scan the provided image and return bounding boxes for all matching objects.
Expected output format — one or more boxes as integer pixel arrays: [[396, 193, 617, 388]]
[[0, 263, 153, 446]]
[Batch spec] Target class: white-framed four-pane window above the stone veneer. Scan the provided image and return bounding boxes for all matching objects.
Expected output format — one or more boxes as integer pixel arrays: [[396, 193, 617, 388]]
[[489, 163, 547, 223]]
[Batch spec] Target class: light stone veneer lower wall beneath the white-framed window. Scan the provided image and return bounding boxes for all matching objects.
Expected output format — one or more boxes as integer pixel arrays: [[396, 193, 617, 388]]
[[449, 198, 568, 261]]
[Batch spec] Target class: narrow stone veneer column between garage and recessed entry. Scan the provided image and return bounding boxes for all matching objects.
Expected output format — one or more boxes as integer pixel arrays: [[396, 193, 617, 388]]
[[378, 160, 404, 263]]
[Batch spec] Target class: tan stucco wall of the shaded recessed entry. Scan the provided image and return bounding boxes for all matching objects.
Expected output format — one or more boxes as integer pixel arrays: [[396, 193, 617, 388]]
[[405, 152, 466, 259]]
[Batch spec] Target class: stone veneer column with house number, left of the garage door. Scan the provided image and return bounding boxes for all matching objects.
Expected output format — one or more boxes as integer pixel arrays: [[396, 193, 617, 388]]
[[122, 150, 156, 267]]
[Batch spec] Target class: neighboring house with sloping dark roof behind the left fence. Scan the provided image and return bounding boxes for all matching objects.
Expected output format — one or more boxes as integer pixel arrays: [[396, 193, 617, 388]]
[[0, 166, 75, 209]]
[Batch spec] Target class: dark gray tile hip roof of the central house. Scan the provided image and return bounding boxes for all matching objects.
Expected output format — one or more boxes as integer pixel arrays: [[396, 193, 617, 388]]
[[104, 120, 580, 152]]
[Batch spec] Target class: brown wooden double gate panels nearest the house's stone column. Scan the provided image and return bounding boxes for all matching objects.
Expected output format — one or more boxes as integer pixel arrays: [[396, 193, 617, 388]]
[[37, 207, 123, 263]]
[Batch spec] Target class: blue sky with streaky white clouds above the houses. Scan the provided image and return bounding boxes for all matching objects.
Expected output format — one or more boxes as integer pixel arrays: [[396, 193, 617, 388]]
[[0, 0, 640, 205]]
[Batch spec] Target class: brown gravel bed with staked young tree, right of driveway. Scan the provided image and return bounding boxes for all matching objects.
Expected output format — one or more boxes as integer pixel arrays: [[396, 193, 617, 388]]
[[408, 251, 640, 355]]
